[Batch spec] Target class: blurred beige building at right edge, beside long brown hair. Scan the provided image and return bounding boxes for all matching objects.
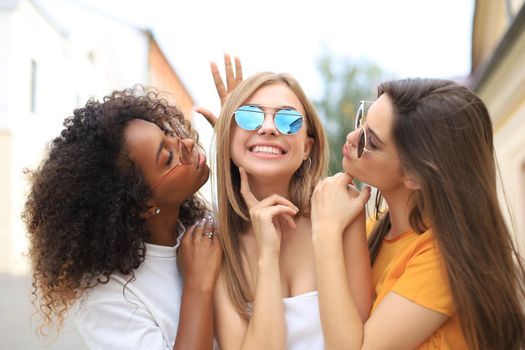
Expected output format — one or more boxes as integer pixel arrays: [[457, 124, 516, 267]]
[[472, 0, 525, 255]]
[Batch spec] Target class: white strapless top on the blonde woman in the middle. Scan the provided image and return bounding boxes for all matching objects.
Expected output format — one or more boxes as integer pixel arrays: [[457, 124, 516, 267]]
[[283, 291, 324, 350]]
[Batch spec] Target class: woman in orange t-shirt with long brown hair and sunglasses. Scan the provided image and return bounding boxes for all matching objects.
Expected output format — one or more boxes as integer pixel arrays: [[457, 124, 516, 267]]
[[312, 79, 525, 350]]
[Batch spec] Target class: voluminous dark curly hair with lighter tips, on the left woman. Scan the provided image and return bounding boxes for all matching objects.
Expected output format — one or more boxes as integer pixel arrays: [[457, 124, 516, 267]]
[[22, 88, 208, 334]]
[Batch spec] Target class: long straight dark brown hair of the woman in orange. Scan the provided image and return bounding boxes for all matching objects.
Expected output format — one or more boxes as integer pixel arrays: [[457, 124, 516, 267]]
[[369, 79, 525, 349]]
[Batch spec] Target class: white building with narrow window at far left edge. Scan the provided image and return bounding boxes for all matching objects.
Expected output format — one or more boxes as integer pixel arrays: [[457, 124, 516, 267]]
[[0, 0, 77, 274]]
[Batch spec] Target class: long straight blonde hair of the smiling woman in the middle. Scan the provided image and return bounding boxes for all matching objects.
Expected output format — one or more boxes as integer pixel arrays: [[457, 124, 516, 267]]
[[215, 72, 328, 319]]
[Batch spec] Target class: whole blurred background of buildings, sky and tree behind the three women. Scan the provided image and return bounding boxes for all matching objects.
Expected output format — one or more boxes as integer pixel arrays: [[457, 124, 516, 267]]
[[4, 0, 525, 350]]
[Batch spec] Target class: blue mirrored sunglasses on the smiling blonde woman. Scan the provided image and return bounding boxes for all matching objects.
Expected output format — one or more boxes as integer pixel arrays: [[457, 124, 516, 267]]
[[234, 106, 304, 135]]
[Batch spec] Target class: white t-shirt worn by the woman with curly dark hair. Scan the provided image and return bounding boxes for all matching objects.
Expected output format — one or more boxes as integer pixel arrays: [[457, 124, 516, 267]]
[[75, 225, 185, 350]]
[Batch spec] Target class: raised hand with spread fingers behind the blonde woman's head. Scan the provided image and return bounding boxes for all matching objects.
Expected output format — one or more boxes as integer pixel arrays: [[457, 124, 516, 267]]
[[195, 54, 242, 126]]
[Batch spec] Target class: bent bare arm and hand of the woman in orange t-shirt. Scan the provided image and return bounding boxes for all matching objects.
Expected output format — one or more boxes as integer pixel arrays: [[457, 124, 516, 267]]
[[312, 175, 448, 350]]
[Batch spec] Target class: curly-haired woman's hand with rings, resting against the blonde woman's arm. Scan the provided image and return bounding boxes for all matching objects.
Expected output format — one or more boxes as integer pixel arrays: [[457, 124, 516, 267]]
[[177, 218, 222, 291]]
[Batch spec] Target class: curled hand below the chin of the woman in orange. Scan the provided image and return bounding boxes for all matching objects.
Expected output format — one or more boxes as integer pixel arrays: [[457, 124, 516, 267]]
[[311, 173, 370, 235]]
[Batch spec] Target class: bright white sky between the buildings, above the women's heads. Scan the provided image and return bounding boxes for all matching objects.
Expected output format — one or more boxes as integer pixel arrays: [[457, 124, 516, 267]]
[[37, 0, 474, 113]]
